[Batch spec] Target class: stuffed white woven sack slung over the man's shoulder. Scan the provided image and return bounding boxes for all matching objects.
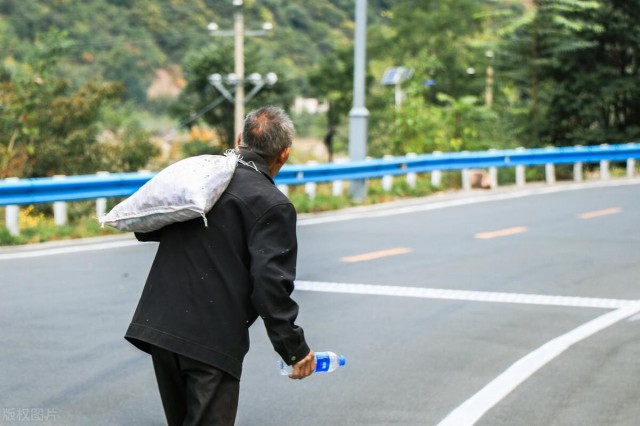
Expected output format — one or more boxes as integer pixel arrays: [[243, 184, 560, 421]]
[[99, 150, 238, 232]]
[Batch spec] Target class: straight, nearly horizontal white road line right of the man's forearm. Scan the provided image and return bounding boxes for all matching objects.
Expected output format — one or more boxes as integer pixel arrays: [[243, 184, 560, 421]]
[[295, 281, 638, 309]]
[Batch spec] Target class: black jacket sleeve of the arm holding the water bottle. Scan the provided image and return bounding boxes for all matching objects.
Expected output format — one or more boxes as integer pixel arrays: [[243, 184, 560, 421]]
[[249, 204, 310, 365]]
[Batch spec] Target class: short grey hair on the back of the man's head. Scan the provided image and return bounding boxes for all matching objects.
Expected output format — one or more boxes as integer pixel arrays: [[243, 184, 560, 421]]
[[240, 106, 295, 161]]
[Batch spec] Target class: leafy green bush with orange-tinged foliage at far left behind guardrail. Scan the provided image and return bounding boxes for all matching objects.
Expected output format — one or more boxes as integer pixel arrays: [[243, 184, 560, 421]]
[[0, 30, 159, 177]]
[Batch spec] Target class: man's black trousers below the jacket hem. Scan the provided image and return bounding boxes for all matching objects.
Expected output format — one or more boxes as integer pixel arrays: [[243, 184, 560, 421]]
[[151, 346, 240, 426]]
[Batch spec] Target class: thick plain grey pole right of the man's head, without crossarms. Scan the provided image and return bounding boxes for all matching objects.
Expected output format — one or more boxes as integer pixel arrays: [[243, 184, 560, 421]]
[[349, 0, 369, 201]]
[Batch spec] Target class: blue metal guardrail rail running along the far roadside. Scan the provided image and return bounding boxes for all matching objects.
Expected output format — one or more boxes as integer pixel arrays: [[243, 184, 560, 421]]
[[0, 143, 640, 206]]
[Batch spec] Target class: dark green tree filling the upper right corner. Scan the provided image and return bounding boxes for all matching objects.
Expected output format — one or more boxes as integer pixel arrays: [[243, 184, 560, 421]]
[[545, 1, 640, 145]]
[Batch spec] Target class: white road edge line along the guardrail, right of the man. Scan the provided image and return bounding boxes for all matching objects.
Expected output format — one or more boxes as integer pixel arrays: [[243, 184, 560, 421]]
[[298, 179, 640, 226]]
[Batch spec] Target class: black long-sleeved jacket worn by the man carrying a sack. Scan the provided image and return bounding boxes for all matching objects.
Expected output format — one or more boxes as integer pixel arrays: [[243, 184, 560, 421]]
[[125, 150, 309, 379]]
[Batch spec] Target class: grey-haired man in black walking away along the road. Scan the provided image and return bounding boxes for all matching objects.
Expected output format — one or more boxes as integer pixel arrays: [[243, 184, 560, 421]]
[[125, 107, 315, 425]]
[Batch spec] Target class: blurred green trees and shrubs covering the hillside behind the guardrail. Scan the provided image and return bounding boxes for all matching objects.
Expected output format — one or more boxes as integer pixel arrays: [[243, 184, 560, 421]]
[[0, 0, 640, 178]]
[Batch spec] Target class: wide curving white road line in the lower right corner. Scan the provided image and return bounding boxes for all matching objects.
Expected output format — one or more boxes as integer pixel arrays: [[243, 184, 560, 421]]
[[438, 303, 640, 426]]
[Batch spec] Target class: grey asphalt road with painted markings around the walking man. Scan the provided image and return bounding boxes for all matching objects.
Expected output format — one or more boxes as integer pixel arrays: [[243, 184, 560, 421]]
[[0, 180, 640, 426]]
